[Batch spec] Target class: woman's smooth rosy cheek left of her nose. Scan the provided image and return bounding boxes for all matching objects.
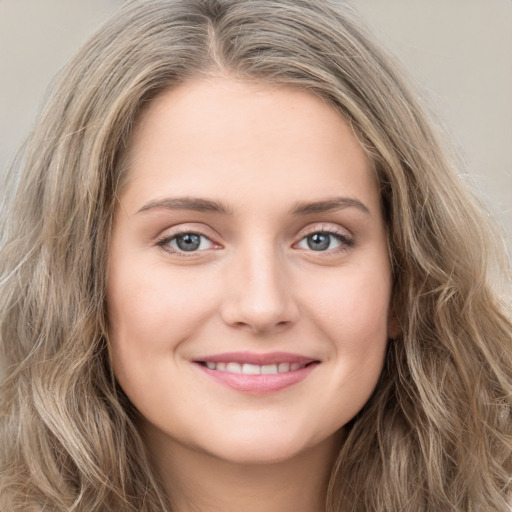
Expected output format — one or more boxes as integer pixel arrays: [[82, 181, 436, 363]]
[[107, 260, 217, 365]]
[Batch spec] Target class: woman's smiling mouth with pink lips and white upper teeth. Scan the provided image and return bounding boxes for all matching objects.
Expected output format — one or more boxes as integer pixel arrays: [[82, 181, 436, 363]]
[[193, 352, 320, 394]]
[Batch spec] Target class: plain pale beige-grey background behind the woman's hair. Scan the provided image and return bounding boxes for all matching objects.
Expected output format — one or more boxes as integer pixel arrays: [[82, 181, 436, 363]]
[[0, 0, 512, 244]]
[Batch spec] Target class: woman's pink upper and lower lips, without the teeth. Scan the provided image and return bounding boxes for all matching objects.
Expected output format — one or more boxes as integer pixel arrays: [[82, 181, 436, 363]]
[[193, 352, 320, 394]]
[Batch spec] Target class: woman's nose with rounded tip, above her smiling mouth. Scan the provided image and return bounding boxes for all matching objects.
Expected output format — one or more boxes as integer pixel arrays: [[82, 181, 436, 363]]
[[221, 245, 299, 333]]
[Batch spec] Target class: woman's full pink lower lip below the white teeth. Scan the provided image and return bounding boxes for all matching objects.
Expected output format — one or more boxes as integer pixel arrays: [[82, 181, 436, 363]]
[[196, 363, 318, 394]]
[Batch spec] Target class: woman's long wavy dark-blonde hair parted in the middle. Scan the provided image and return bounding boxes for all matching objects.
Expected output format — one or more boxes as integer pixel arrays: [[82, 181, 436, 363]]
[[0, 0, 512, 512]]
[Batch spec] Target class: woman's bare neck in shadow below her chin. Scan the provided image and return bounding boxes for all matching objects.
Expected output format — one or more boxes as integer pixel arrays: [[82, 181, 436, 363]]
[[142, 422, 339, 512]]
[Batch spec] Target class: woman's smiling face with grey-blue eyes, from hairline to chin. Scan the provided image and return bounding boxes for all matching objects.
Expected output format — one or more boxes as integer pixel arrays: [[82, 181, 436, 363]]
[[107, 78, 392, 463]]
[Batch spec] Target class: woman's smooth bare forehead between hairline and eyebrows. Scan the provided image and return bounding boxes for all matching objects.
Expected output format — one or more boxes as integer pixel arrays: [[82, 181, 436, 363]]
[[123, 78, 379, 217]]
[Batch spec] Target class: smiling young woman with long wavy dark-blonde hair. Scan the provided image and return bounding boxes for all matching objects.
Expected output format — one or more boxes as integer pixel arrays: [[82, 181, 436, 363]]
[[0, 0, 512, 512]]
